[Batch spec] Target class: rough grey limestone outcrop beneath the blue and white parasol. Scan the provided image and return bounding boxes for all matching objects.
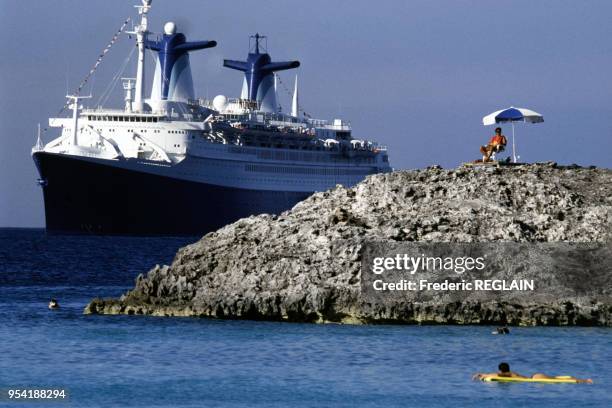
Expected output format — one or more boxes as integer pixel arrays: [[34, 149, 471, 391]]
[[85, 163, 612, 326]]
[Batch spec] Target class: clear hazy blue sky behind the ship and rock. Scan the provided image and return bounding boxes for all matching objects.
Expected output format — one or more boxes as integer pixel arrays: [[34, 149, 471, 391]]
[[0, 0, 612, 227]]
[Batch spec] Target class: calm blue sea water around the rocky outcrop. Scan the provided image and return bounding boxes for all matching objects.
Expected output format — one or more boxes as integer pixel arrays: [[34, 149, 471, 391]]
[[0, 229, 612, 407]]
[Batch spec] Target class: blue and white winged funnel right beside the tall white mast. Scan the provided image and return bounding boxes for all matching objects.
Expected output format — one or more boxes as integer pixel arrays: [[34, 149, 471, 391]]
[[145, 22, 217, 102]]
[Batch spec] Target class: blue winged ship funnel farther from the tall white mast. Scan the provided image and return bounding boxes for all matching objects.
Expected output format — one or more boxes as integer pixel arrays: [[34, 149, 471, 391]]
[[223, 34, 300, 112]]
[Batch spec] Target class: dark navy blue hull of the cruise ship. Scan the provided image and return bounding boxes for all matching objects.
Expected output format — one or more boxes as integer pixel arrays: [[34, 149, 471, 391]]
[[33, 152, 311, 235]]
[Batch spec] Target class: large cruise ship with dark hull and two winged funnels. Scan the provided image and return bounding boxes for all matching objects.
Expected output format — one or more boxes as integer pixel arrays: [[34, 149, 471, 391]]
[[32, 0, 391, 235]]
